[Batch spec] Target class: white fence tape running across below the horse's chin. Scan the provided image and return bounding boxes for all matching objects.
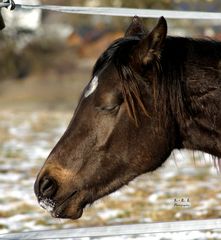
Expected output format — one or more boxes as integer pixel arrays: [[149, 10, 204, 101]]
[[0, 219, 221, 240]]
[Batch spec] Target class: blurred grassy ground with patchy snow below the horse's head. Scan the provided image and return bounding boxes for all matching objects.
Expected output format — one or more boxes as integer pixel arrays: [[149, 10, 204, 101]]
[[0, 111, 221, 240]]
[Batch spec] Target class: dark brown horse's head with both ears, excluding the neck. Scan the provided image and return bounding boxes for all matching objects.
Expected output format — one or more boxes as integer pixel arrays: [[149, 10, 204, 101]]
[[35, 17, 178, 219]]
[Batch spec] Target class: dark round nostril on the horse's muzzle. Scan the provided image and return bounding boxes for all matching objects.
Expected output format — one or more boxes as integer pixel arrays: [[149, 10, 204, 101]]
[[39, 177, 58, 198]]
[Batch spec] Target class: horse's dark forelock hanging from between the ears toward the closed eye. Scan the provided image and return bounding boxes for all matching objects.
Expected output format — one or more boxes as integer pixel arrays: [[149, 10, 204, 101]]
[[93, 36, 148, 125]]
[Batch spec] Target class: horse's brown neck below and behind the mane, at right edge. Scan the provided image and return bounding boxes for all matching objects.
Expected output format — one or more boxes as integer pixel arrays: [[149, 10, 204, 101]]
[[181, 40, 221, 157]]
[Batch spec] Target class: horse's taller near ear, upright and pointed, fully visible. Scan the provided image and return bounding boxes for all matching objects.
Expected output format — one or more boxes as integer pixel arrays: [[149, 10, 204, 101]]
[[136, 17, 167, 65]]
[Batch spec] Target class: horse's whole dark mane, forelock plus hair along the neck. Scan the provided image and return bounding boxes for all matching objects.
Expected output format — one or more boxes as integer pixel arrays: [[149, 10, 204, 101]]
[[93, 36, 221, 171]]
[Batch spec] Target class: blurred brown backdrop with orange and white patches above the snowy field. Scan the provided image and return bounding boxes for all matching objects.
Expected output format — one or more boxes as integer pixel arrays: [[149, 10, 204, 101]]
[[0, 0, 221, 109]]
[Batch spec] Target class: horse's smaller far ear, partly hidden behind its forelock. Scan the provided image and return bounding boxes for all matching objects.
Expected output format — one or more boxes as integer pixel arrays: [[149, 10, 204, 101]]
[[124, 16, 146, 37]]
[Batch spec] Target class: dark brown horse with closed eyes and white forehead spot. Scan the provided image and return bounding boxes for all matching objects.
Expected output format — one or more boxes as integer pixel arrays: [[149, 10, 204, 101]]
[[35, 17, 221, 219]]
